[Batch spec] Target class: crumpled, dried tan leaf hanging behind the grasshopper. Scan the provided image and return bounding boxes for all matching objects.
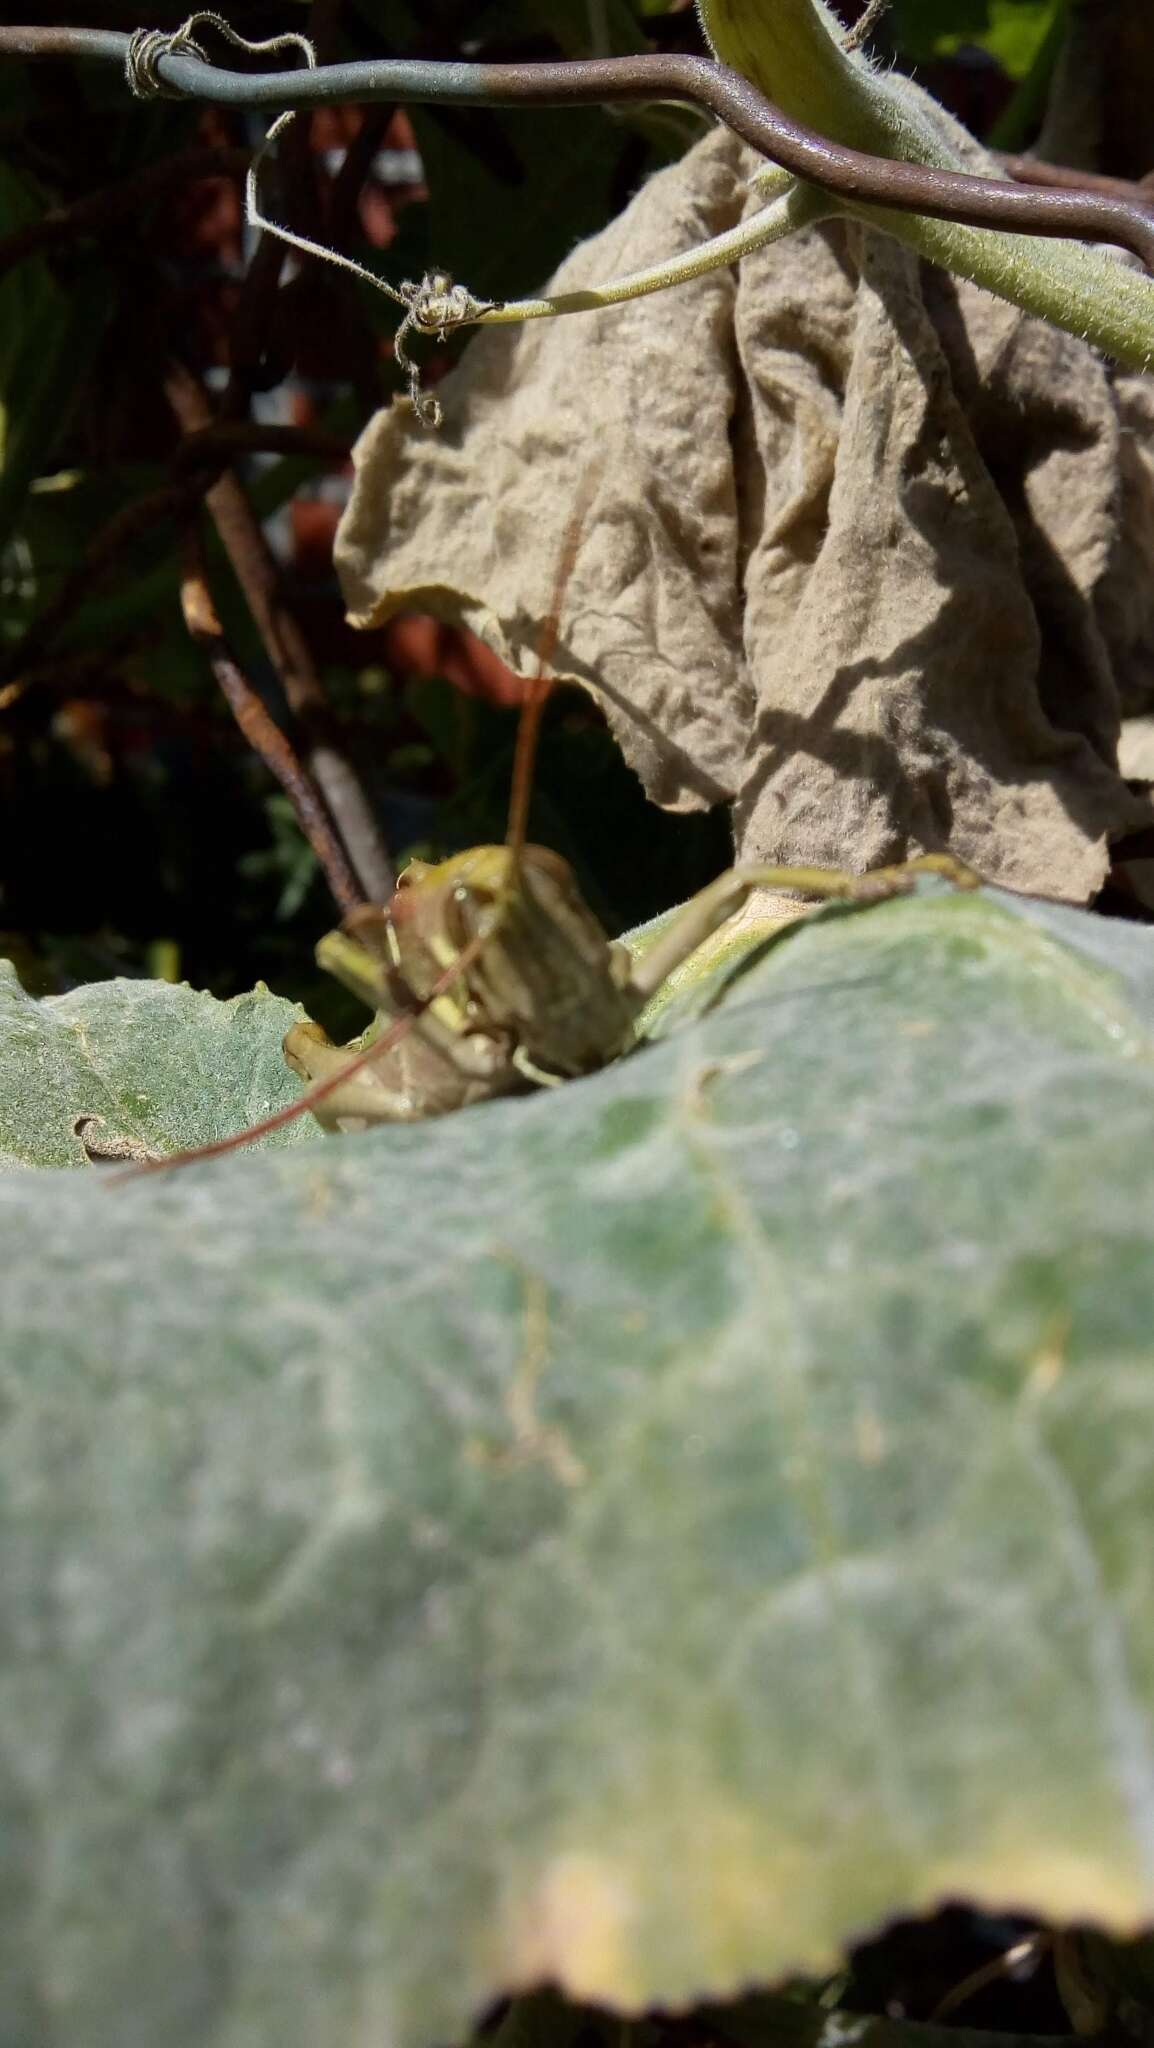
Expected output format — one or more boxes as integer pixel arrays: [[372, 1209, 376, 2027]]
[[338, 131, 1154, 899]]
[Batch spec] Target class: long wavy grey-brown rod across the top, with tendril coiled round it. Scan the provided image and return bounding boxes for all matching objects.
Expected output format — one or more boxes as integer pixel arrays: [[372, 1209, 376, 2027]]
[[0, 27, 1154, 270]]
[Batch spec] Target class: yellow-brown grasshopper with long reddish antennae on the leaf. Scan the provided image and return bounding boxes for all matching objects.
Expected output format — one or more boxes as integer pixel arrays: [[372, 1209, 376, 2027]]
[[129, 485, 980, 1174]]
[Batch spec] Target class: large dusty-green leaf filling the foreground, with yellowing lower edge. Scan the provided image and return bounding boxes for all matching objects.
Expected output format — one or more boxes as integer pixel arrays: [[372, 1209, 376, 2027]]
[[0, 895, 1154, 2048]]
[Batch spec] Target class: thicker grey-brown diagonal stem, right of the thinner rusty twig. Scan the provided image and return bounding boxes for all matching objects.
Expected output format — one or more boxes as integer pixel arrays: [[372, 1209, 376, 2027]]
[[164, 362, 396, 903]]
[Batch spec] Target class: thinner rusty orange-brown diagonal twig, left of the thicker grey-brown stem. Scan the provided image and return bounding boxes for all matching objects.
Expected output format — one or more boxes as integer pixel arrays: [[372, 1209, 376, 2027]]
[[180, 535, 365, 918]]
